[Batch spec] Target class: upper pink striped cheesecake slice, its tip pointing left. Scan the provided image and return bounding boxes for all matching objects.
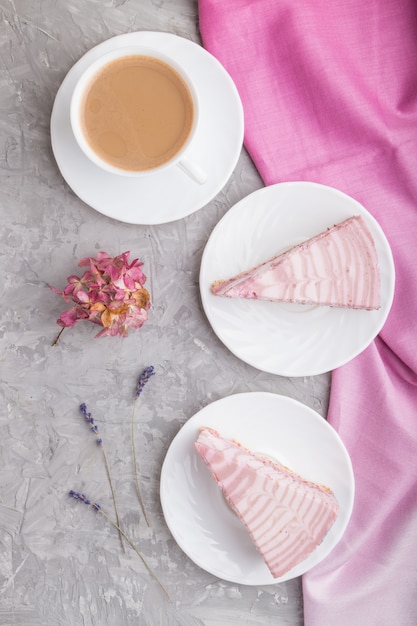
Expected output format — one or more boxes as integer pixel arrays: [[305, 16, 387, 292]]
[[211, 215, 381, 310]]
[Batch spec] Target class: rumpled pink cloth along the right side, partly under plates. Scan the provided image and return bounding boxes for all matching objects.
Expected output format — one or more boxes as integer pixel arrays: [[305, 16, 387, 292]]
[[199, 0, 417, 626]]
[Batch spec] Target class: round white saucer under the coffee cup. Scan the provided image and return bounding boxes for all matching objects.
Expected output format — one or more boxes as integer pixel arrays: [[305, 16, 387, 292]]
[[51, 31, 243, 224]]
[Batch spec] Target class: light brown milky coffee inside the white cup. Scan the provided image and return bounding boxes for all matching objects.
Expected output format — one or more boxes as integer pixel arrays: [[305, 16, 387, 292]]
[[81, 55, 194, 171]]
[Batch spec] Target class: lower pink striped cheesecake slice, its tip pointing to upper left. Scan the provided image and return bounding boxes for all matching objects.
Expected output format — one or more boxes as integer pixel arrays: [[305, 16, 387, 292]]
[[195, 428, 339, 578]]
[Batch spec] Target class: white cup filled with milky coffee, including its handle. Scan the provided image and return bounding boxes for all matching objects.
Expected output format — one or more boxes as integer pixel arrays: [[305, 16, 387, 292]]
[[71, 46, 205, 183]]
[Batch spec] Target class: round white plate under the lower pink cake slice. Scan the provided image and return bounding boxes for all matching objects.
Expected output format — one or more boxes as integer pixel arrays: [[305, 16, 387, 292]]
[[161, 392, 354, 585]]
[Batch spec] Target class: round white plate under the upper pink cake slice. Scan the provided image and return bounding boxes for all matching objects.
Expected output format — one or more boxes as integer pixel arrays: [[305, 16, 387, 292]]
[[200, 182, 395, 376]]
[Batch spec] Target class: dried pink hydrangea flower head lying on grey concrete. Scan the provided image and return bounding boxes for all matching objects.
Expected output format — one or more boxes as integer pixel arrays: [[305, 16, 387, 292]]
[[51, 252, 150, 344]]
